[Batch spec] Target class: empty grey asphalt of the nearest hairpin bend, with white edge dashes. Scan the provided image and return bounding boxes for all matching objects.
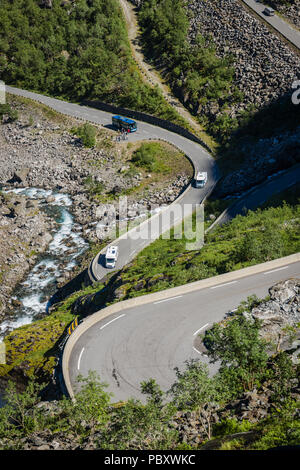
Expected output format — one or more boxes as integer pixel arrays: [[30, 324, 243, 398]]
[[69, 262, 300, 402]]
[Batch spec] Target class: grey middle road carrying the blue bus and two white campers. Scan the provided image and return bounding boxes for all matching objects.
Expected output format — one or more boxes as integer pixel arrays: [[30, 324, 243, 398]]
[[6, 86, 218, 280]]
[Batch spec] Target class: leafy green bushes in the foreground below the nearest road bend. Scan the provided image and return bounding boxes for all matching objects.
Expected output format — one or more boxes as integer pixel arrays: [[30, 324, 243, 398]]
[[0, 310, 300, 450]]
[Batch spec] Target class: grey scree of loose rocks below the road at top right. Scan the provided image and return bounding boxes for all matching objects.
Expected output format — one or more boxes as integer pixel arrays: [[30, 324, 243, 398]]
[[188, 0, 300, 116]]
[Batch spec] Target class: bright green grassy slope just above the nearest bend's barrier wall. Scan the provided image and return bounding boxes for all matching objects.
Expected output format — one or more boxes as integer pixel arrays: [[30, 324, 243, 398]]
[[102, 194, 300, 301]]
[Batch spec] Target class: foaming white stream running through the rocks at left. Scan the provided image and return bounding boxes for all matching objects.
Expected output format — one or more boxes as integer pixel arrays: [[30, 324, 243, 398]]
[[0, 188, 88, 338]]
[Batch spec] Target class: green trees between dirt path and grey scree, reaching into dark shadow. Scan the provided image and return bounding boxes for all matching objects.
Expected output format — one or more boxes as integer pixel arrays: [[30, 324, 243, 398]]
[[138, 0, 300, 156]]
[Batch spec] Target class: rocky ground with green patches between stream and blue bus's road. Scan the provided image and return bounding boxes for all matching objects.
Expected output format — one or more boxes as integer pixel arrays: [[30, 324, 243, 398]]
[[0, 97, 192, 241]]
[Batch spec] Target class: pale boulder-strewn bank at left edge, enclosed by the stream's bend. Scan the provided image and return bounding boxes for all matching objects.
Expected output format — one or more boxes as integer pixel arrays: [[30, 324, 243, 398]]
[[0, 194, 53, 319]]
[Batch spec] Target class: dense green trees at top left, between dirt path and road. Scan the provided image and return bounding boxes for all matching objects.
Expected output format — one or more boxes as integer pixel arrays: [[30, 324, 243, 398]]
[[0, 0, 188, 126]]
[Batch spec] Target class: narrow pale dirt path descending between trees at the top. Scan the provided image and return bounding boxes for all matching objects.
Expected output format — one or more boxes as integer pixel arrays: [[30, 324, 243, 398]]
[[120, 0, 212, 146]]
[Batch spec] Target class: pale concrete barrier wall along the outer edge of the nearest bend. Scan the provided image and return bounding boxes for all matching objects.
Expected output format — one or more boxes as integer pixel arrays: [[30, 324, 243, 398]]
[[62, 253, 300, 399]]
